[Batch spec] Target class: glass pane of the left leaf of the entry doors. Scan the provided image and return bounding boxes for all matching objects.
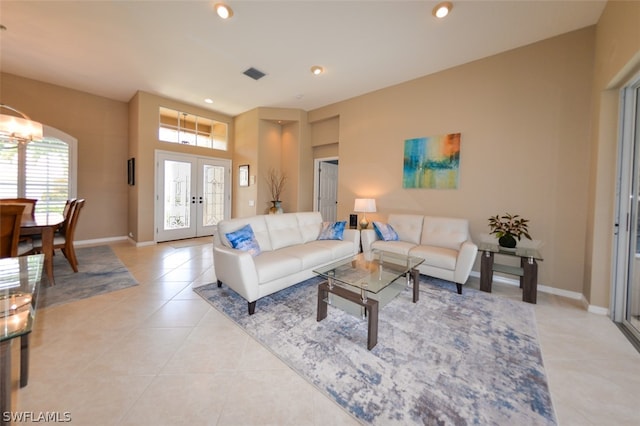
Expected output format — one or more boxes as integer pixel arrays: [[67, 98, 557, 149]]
[[164, 160, 191, 230]]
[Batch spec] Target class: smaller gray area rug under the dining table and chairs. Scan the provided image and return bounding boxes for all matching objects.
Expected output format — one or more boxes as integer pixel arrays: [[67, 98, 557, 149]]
[[37, 246, 138, 309]]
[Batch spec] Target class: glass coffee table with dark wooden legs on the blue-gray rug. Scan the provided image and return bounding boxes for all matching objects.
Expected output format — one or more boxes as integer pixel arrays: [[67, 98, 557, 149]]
[[313, 250, 424, 350]]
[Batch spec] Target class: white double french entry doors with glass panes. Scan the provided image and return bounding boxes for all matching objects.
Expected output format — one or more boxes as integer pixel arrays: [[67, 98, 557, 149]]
[[155, 151, 231, 241]]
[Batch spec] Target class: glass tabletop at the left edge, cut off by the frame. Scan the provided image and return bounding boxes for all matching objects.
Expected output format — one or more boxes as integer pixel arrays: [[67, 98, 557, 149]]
[[0, 254, 44, 341]]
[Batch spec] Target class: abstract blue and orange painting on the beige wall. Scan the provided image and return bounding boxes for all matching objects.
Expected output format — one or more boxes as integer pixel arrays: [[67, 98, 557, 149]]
[[402, 133, 460, 189]]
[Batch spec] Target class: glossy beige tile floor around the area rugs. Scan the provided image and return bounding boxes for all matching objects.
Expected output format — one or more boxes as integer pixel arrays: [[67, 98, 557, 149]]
[[7, 238, 640, 426]]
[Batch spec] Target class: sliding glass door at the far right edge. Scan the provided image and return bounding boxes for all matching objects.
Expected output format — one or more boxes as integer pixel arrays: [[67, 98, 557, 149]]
[[612, 75, 640, 344]]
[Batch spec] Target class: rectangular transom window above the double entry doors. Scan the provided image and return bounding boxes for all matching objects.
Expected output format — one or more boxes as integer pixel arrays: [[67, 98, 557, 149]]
[[158, 107, 228, 151]]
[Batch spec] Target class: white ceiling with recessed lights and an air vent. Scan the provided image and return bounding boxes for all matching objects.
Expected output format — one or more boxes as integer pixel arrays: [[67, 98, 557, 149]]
[[0, 0, 606, 116]]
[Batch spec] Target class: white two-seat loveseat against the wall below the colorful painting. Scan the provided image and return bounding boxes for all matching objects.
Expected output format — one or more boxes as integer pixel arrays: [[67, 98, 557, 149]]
[[361, 214, 478, 294]]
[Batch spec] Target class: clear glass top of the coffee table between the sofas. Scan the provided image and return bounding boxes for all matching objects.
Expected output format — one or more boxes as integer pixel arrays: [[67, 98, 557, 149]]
[[313, 250, 424, 293]]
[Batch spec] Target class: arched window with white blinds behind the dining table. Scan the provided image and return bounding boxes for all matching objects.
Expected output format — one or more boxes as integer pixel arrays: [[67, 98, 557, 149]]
[[0, 125, 78, 213]]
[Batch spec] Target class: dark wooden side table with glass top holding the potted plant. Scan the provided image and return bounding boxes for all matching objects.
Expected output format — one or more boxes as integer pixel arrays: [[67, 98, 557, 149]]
[[478, 243, 543, 303]]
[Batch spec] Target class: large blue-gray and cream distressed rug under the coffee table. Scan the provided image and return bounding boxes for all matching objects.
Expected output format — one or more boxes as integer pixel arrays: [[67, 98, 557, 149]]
[[195, 276, 557, 426]]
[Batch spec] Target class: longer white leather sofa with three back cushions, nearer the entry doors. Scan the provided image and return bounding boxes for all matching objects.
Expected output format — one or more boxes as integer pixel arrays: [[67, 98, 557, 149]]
[[213, 212, 360, 315]]
